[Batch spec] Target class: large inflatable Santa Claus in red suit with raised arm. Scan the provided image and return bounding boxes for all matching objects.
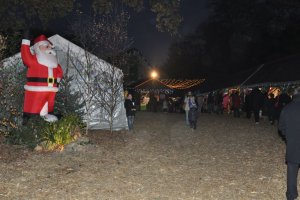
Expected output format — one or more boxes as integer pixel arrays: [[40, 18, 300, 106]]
[[21, 35, 63, 122]]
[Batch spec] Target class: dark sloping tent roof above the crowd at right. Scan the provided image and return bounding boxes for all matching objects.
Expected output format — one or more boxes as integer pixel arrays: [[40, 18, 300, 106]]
[[199, 54, 300, 92]]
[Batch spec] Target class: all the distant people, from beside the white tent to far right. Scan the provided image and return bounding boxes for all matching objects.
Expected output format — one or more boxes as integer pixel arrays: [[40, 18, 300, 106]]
[[125, 87, 292, 129]]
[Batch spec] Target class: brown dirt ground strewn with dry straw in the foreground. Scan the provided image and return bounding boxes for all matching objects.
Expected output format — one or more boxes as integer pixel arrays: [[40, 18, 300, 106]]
[[0, 112, 286, 200]]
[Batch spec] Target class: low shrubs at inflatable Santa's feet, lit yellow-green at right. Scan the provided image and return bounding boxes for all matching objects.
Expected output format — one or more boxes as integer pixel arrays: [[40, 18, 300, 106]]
[[6, 115, 83, 150]]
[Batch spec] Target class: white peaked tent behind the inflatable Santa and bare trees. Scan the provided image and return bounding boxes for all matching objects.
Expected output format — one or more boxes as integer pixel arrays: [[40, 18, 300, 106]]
[[4, 35, 128, 130]]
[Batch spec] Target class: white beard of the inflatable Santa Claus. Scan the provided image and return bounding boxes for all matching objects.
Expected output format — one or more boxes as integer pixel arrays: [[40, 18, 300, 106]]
[[35, 48, 58, 68]]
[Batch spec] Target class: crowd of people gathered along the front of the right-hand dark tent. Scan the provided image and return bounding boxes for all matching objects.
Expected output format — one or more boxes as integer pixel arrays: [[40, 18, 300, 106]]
[[197, 87, 292, 124]]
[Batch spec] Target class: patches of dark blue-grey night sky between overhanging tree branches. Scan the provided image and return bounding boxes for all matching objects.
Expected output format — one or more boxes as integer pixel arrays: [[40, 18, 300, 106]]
[[129, 0, 208, 66]]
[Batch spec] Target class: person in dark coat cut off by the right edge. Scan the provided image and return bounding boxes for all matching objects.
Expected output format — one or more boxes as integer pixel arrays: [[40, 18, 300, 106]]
[[278, 87, 300, 200]]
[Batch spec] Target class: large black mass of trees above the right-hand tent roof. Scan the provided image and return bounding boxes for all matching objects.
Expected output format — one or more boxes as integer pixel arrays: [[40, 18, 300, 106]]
[[164, 0, 300, 86]]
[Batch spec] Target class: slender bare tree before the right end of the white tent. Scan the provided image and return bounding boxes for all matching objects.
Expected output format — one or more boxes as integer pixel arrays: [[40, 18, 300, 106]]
[[92, 7, 132, 131]]
